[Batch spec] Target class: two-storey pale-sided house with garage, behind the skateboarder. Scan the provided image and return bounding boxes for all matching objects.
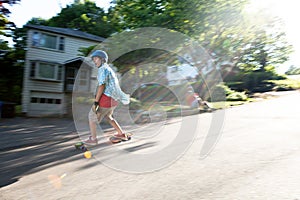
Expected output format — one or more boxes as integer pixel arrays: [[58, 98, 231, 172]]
[[22, 25, 104, 117]]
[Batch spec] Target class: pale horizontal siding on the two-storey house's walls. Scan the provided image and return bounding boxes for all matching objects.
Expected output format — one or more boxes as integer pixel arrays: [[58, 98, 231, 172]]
[[22, 29, 99, 117]]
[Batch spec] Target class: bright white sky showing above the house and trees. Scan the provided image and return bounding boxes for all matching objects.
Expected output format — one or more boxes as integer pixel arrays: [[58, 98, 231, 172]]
[[5, 0, 300, 73]]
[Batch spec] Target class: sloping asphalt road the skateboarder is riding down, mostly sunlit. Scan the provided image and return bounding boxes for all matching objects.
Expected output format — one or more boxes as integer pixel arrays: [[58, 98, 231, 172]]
[[0, 91, 300, 200]]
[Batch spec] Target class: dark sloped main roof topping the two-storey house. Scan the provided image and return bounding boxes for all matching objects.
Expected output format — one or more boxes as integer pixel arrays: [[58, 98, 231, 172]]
[[25, 24, 105, 42]]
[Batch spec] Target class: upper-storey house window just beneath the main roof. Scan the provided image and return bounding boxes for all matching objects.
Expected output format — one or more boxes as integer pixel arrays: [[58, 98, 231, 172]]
[[32, 32, 65, 51]]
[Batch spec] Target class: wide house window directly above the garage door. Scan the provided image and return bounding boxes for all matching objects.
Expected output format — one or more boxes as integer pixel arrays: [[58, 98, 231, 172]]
[[30, 61, 63, 81]]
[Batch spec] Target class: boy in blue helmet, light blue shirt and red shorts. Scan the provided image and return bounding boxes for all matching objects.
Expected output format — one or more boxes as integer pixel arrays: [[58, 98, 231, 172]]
[[80, 50, 130, 145]]
